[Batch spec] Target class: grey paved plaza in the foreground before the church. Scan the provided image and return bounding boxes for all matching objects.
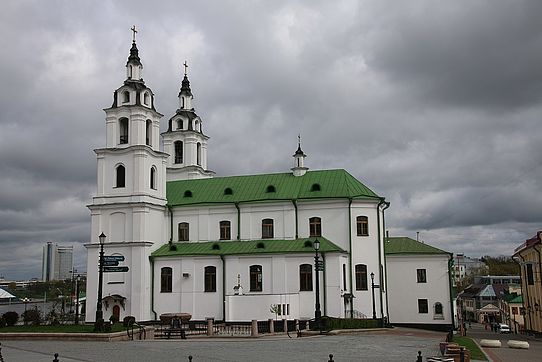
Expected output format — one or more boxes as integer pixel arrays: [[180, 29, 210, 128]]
[[1, 330, 444, 362]]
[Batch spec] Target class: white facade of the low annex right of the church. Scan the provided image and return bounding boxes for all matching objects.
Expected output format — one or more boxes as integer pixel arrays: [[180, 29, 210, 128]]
[[386, 253, 454, 328]]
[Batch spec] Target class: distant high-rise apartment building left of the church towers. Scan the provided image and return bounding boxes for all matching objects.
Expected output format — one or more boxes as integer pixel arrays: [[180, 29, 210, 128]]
[[41, 241, 73, 282]]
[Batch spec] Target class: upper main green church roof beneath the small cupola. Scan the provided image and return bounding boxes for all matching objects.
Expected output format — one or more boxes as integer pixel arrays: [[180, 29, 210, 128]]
[[166, 170, 380, 206]]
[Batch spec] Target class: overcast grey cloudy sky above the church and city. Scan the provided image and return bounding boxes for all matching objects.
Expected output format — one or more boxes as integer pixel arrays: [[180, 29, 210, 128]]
[[0, 0, 542, 279]]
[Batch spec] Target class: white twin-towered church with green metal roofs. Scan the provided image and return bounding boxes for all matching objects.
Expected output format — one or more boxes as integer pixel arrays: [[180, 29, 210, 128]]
[[86, 34, 389, 322]]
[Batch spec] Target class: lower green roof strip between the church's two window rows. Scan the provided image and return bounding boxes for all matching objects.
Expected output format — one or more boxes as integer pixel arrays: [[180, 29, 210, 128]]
[[151, 237, 344, 257]]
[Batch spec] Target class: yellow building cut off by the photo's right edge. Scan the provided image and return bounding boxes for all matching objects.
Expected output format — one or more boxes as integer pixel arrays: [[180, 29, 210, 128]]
[[514, 231, 542, 334]]
